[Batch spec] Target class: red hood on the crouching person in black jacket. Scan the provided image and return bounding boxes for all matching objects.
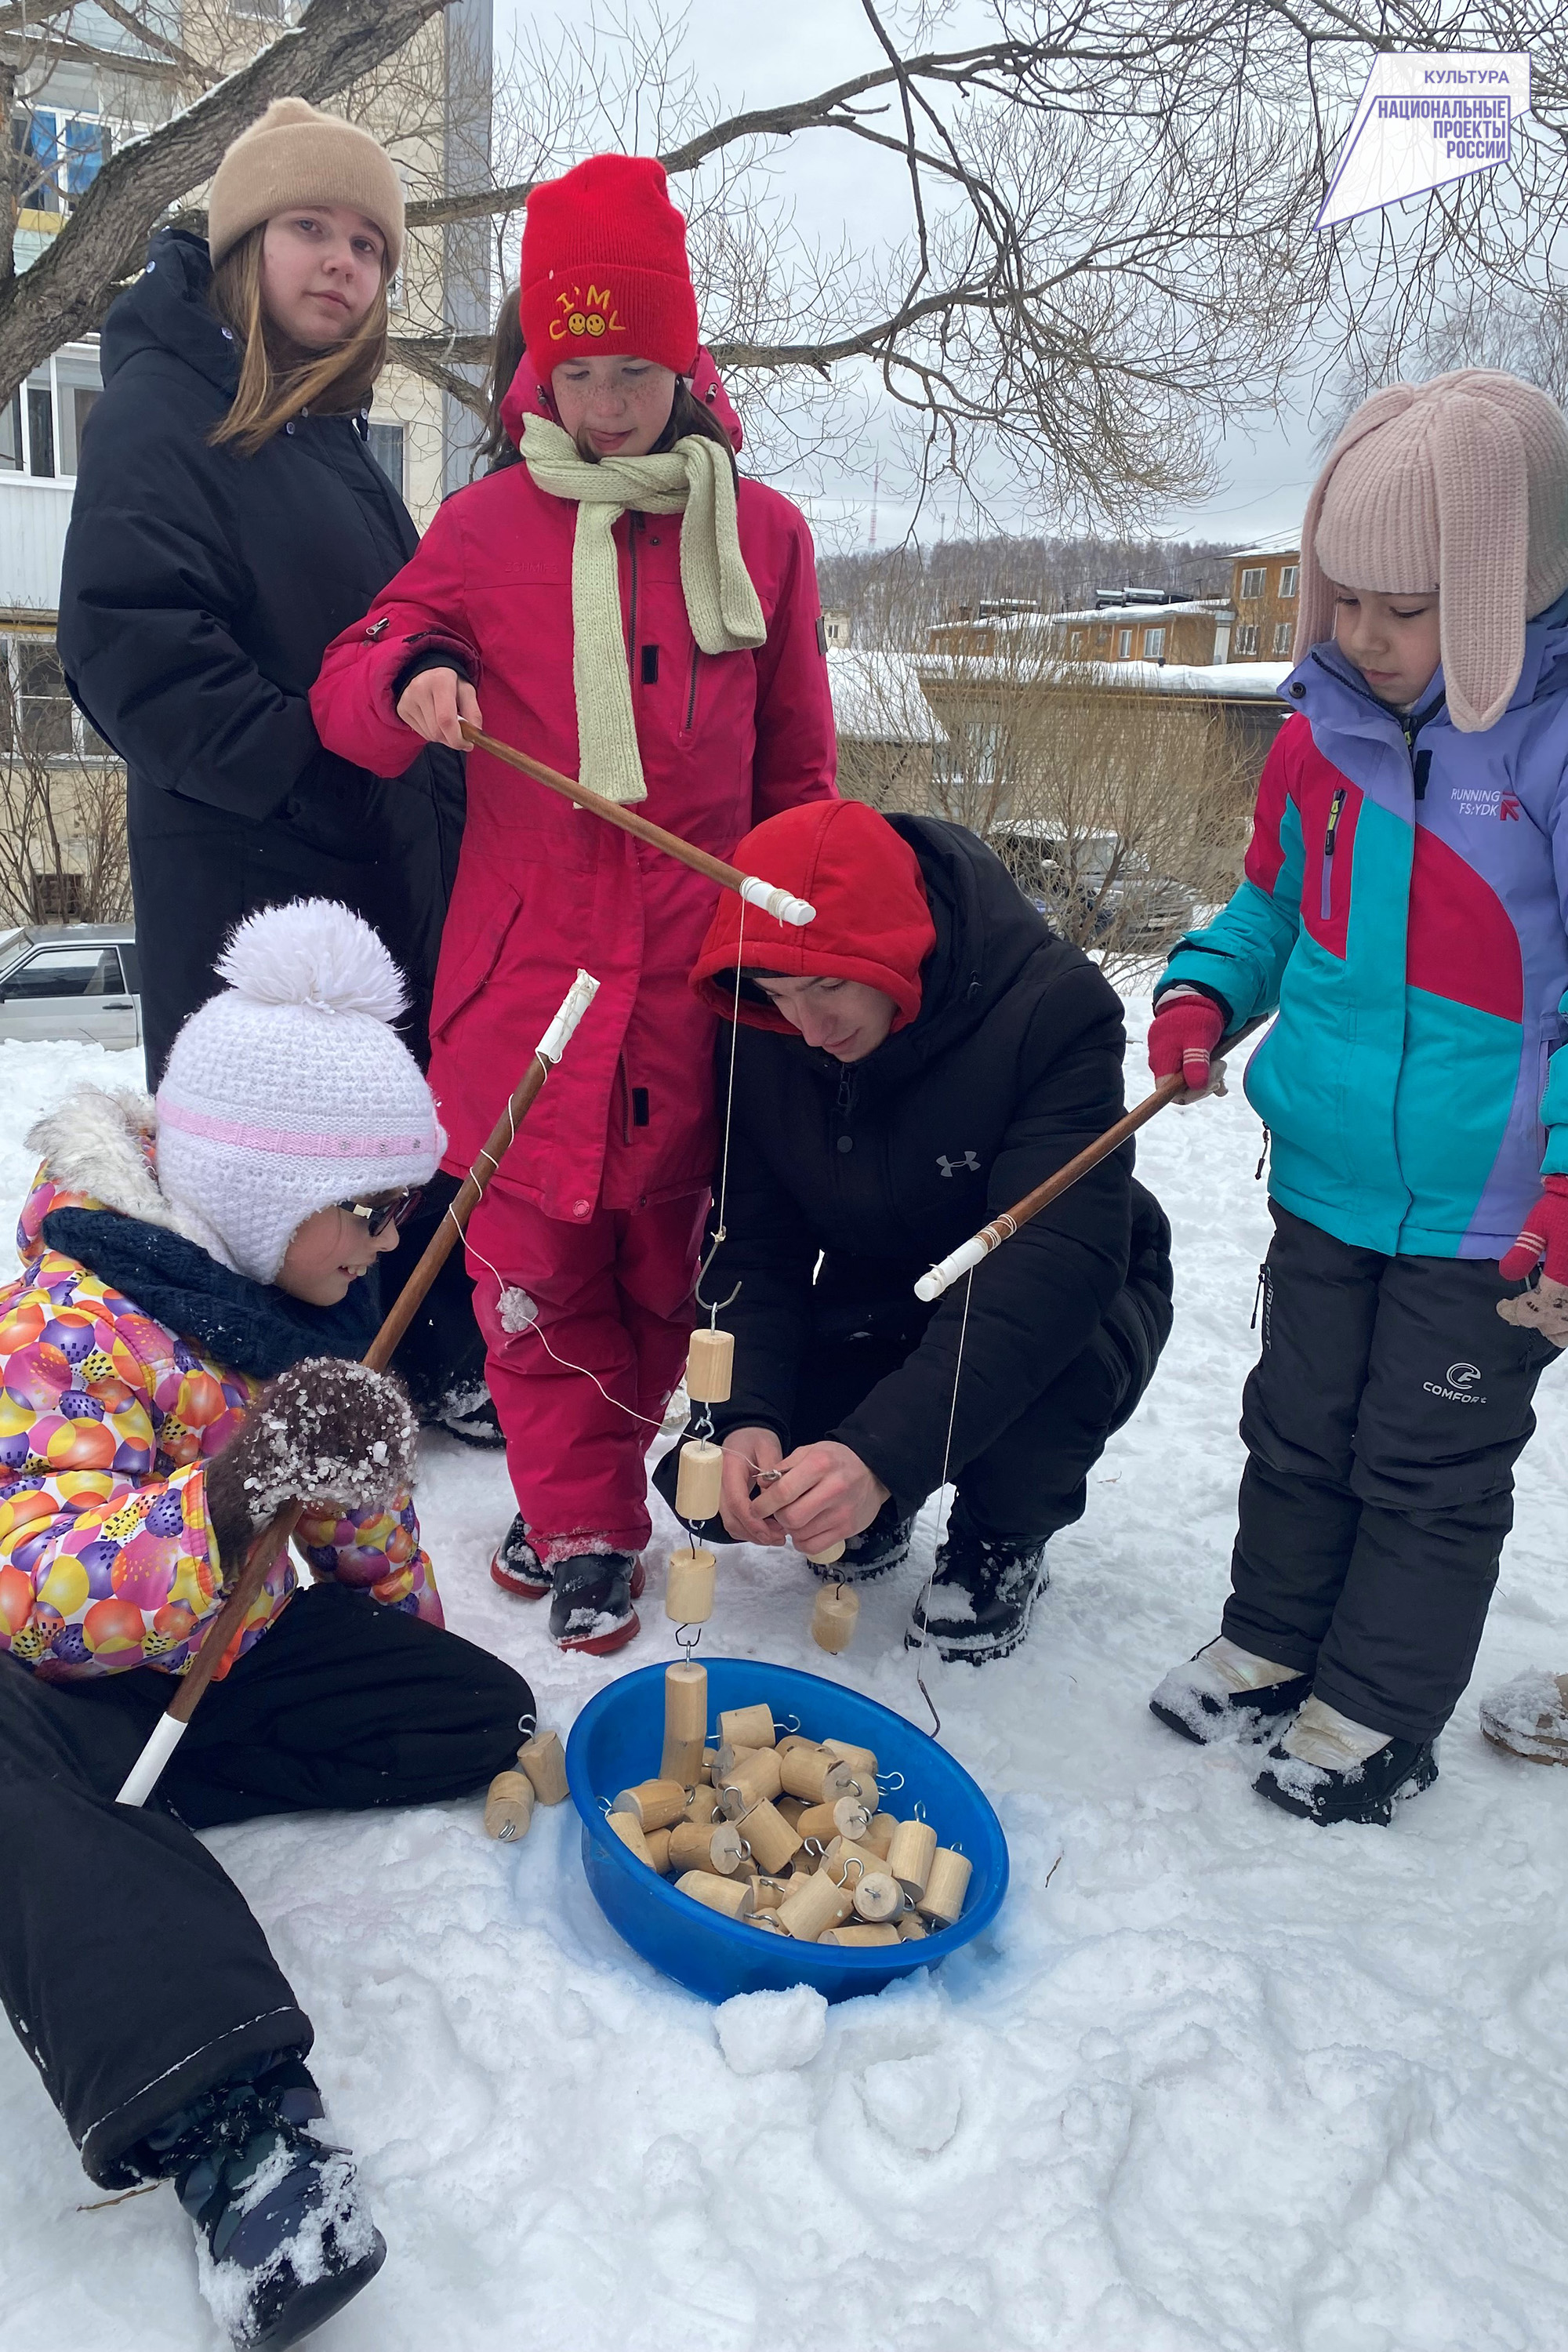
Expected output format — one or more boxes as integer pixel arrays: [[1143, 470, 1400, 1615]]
[[691, 800, 935, 1035]]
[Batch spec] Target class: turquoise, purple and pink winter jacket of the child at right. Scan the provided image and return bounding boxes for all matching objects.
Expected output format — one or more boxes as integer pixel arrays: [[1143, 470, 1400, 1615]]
[[1156, 597, 1568, 1258]]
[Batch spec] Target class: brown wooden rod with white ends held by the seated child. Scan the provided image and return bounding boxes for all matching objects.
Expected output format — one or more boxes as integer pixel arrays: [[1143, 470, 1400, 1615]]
[[115, 971, 600, 1804]]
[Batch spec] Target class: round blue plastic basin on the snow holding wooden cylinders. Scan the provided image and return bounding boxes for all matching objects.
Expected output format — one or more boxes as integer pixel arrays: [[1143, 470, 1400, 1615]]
[[567, 1658, 1006, 2002]]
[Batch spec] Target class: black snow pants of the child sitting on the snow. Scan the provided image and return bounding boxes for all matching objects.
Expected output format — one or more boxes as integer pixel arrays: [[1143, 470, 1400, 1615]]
[[0, 1585, 534, 2187]]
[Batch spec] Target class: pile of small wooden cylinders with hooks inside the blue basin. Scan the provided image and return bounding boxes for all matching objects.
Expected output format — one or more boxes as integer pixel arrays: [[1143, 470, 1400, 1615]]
[[607, 1661, 971, 1945]]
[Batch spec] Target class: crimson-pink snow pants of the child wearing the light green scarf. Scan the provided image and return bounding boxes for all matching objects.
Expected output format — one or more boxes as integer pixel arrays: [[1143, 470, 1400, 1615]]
[[468, 1185, 708, 1559]]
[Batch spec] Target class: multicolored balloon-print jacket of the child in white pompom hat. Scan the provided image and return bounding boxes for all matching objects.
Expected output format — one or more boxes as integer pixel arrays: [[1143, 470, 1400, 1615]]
[[0, 1096, 442, 1682]]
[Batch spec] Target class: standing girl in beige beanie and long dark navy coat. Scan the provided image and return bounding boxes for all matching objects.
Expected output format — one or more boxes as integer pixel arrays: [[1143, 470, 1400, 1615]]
[[59, 99, 485, 1432]]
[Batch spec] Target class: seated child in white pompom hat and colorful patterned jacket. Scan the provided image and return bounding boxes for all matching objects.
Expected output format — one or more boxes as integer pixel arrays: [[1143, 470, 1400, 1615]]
[[0, 901, 534, 2347]]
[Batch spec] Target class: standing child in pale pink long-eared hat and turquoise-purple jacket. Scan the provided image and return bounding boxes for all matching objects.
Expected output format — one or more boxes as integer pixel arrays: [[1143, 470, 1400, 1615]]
[[1149, 369, 1568, 1823]]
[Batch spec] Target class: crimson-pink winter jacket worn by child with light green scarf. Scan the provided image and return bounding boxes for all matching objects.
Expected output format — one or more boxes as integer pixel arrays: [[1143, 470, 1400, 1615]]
[[310, 353, 834, 1218]]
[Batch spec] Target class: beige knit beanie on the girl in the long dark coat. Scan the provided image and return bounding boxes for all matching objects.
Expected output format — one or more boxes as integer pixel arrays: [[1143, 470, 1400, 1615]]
[[207, 99, 402, 278]]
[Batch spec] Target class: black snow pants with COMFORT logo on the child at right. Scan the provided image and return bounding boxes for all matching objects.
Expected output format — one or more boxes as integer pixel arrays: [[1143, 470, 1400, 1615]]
[[1225, 1204, 1559, 1740]]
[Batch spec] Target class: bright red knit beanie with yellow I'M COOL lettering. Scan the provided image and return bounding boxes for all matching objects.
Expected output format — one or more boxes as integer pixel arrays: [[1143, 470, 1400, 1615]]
[[522, 155, 699, 383]]
